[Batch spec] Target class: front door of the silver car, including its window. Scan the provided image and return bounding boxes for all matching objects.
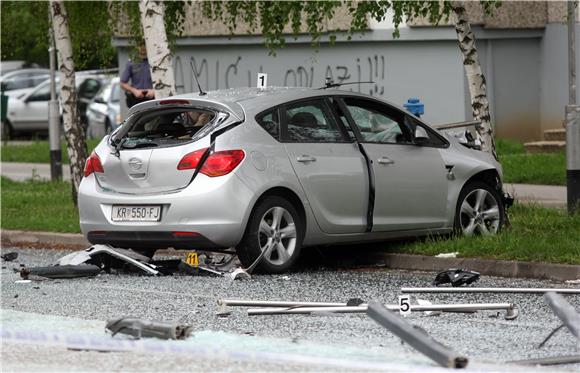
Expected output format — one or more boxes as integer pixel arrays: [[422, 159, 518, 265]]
[[342, 97, 448, 232]]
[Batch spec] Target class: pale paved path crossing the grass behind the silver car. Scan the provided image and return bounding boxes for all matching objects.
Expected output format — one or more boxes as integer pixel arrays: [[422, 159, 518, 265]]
[[0, 162, 566, 208]]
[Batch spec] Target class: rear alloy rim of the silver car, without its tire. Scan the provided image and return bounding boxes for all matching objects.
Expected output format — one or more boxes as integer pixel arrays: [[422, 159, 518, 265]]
[[258, 206, 296, 265]]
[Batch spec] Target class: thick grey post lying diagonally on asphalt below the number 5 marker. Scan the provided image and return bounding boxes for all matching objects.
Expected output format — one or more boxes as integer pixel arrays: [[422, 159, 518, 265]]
[[366, 302, 468, 368]]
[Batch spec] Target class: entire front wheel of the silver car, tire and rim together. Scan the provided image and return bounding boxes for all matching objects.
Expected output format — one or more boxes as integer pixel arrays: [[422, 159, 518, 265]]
[[454, 181, 505, 236]]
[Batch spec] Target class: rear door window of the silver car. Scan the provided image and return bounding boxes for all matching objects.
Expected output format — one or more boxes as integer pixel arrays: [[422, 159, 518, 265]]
[[285, 100, 347, 143]]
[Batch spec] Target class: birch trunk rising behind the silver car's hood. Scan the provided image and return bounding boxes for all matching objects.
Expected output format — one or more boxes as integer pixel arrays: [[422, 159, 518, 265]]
[[452, 1, 497, 158]]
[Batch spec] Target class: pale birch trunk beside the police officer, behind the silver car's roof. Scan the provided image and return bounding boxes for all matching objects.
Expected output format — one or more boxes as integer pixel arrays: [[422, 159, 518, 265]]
[[139, 0, 175, 98]]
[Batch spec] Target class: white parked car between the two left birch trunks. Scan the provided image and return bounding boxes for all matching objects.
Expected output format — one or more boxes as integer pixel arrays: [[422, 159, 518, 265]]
[[87, 77, 121, 139]]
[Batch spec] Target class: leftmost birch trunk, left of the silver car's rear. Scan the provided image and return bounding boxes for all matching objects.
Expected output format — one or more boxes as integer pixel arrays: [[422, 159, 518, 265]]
[[50, 0, 87, 206]]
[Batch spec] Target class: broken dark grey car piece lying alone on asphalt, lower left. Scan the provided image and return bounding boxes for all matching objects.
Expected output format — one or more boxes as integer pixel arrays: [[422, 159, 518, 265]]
[[105, 317, 192, 339]]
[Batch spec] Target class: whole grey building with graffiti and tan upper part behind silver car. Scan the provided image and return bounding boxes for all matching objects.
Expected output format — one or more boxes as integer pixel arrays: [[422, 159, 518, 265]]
[[116, 1, 580, 141]]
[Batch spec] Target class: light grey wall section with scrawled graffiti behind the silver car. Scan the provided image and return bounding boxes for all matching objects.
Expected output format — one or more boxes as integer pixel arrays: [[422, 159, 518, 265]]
[[119, 36, 466, 123]]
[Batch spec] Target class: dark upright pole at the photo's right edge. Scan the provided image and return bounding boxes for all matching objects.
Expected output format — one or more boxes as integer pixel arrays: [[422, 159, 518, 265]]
[[566, 1, 580, 214]]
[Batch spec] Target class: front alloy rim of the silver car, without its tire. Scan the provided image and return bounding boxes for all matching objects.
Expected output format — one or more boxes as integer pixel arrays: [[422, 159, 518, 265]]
[[459, 189, 501, 236]]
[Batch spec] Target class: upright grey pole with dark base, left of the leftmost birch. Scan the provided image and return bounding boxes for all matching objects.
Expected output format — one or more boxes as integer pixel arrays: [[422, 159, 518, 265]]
[[48, 12, 62, 181]]
